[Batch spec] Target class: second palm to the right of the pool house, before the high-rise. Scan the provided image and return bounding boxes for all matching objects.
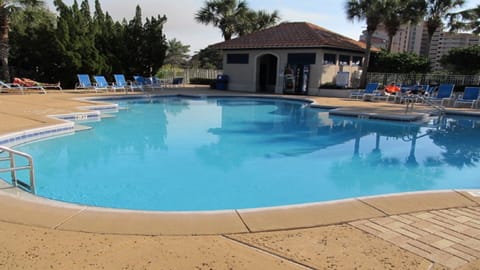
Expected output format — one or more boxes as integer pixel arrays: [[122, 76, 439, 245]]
[[383, 0, 427, 52]]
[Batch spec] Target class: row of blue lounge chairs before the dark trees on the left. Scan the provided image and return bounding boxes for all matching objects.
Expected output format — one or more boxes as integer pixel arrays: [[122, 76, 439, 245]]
[[75, 74, 183, 92]]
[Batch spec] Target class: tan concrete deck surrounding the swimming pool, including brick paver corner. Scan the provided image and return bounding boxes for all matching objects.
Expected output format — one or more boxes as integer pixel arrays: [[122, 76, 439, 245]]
[[0, 88, 480, 269]]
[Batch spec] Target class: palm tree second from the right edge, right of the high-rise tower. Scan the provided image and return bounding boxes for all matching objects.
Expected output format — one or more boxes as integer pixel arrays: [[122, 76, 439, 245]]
[[426, 0, 465, 56]]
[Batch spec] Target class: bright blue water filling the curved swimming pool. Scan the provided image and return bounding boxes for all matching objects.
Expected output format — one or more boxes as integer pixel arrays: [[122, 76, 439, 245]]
[[5, 97, 480, 211]]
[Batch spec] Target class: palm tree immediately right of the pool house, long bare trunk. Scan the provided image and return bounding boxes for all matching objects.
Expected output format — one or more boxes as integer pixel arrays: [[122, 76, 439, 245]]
[[345, 0, 388, 87]]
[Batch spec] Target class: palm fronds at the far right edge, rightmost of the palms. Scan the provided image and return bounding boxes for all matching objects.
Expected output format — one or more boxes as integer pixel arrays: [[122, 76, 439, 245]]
[[448, 5, 480, 35]]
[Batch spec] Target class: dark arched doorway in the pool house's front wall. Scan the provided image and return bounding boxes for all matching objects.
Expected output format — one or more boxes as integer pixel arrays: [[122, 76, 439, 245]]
[[256, 54, 278, 93]]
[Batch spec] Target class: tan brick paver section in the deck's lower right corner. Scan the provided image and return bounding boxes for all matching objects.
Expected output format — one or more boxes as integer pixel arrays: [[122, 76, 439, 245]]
[[350, 207, 480, 268]]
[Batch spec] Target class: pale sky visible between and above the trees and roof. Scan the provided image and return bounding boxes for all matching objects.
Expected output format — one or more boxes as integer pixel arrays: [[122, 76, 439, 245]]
[[45, 0, 477, 54]]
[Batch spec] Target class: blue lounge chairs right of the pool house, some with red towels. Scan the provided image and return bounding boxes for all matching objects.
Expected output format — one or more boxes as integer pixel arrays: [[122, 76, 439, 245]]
[[350, 83, 480, 109]]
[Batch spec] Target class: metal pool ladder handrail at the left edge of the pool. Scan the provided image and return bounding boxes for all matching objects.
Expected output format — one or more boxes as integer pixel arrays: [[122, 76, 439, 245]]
[[0, 145, 36, 194]]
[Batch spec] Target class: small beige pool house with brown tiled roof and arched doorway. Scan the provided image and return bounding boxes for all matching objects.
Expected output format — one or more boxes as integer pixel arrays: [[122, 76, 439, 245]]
[[211, 22, 372, 94]]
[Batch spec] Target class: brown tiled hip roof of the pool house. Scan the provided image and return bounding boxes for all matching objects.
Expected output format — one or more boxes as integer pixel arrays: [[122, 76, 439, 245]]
[[211, 22, 372, 52]]
